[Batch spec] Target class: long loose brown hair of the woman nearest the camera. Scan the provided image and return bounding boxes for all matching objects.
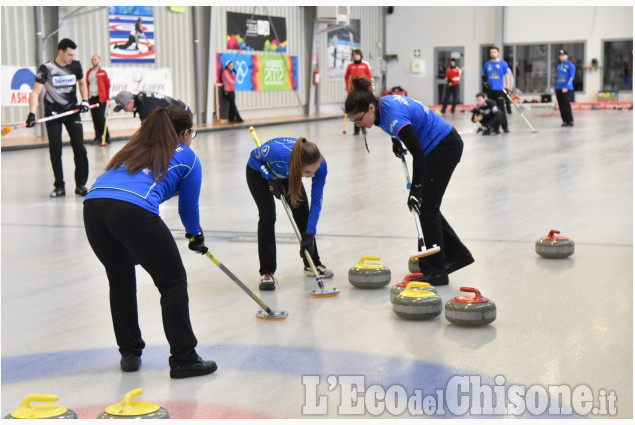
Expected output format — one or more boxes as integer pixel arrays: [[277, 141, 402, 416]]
[[106, 105, 192, 180]]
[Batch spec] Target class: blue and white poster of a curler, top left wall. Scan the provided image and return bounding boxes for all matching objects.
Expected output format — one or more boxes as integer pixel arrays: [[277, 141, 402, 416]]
[[108, 6, 156, 63]]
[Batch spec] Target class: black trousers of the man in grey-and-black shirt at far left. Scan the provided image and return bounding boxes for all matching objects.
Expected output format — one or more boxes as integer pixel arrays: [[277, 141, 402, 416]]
[[44, 105, 88, 188]]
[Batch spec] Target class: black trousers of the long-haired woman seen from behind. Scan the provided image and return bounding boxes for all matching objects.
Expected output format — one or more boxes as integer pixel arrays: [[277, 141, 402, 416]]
[[84, 199, 197, 365]]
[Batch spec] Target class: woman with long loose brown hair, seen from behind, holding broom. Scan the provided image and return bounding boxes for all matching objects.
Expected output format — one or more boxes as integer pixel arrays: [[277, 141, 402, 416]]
[[84, 106, 216, 378]]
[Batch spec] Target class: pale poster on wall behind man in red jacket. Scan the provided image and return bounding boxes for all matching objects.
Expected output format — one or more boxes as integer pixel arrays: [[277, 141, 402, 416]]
[[326, 19, 361, 84]]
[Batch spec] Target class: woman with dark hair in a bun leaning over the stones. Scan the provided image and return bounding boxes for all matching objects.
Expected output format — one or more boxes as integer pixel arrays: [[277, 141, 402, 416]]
[[344, 77, 474, 285]]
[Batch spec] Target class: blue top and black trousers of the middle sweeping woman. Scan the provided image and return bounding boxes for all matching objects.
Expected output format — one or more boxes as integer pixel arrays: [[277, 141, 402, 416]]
[[247, 137, 328, 276]]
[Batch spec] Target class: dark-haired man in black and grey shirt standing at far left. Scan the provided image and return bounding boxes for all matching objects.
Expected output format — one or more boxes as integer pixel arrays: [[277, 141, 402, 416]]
[[26, 38, 89, 198]]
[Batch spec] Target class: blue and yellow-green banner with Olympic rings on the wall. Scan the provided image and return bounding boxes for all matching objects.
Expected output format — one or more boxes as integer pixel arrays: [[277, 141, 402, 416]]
[[216, 53, 298, 91]]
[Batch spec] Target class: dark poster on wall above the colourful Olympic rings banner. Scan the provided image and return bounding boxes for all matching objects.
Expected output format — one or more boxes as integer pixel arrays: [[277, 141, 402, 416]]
[[227, 12, 287, 52]]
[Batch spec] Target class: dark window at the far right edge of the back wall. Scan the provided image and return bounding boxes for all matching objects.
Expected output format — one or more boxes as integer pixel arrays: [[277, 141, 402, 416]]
[[602, 39, 633, 92]]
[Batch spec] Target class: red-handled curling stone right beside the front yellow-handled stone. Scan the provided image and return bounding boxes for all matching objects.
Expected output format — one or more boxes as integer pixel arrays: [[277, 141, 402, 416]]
[[445, 286, 496, 326]]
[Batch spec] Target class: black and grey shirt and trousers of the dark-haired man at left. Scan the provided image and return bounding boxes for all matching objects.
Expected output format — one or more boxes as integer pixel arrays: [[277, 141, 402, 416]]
[[35, 60, 88, 189]]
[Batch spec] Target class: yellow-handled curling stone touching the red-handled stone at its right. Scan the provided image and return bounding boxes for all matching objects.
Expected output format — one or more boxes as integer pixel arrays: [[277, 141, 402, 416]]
[[392, 282, 443, 320]]
